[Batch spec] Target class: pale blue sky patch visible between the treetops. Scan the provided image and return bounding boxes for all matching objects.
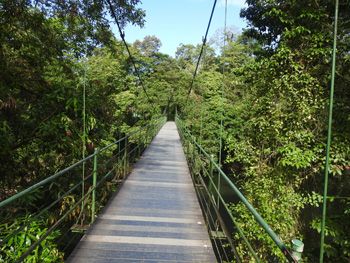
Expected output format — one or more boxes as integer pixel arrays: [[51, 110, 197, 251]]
[[113, 0, 246, 57]]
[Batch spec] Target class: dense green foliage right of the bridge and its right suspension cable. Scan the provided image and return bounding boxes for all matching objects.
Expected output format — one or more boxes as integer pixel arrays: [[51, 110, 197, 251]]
[[174, 1, 350, 262]]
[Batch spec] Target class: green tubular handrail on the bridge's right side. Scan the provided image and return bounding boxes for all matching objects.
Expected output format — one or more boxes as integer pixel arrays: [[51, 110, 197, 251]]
[[175, 116, 303, 262]]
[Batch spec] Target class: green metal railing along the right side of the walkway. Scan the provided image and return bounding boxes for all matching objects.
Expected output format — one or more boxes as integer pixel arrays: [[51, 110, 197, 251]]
[[175, 117, 304, 262]]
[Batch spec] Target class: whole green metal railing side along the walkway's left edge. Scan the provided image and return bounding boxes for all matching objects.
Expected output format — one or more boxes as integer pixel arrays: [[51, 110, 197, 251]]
[[0, 116, 166, 262]]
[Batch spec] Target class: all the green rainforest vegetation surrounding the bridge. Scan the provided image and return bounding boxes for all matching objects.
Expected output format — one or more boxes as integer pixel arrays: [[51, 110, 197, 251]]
[[0, 0, 350, 262]]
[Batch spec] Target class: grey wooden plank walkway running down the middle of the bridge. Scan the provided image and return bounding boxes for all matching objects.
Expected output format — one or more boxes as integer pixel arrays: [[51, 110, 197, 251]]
[[66, 122, 217, 263]]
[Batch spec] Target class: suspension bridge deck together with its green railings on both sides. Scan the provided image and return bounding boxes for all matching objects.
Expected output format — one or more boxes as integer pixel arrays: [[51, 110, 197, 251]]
[[0, 116, 303, 262]]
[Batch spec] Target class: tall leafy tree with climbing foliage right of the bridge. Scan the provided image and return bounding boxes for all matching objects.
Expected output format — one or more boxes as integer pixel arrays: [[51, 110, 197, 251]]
[[232, 1, 350, 262]]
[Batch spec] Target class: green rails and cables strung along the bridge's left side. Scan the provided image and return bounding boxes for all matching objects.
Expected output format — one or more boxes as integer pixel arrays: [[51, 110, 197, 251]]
[[0, 116, 166, 262]]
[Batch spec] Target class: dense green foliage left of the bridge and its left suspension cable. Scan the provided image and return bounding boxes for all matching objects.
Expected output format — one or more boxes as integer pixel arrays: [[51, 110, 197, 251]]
[[0, 0, 155, 262]]
